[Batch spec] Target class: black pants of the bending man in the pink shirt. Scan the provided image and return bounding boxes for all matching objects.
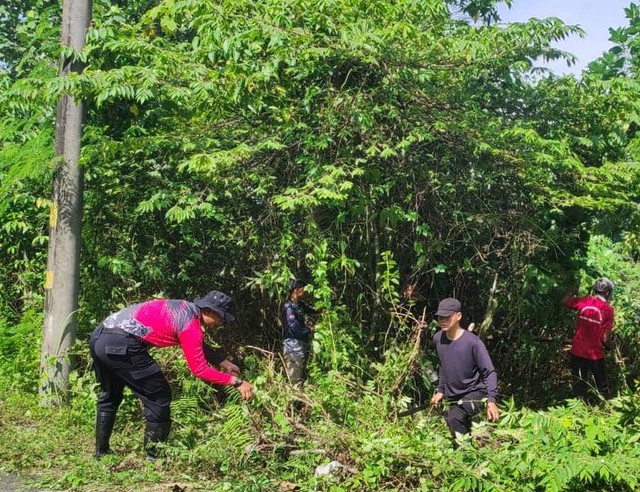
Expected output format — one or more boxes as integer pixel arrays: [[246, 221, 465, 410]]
[[89, 325, 171, 423]]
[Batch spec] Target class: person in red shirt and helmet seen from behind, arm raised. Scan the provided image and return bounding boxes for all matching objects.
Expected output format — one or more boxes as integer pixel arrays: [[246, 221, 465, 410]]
[[562, 278, 614, 399]]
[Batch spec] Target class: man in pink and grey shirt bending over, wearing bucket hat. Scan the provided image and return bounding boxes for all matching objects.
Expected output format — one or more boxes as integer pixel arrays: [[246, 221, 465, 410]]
[[89, 290, 253, 461]]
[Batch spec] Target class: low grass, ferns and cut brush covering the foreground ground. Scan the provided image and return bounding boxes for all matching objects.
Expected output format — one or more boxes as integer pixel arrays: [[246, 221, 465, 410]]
[[0, 348, 640, 491]]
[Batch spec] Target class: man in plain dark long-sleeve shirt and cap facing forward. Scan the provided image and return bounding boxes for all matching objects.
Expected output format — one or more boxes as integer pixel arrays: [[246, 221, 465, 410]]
[[431, 298, 499, 447]]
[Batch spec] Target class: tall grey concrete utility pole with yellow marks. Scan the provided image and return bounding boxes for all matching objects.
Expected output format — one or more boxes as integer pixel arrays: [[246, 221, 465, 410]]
[[40, 0, 92, 405]]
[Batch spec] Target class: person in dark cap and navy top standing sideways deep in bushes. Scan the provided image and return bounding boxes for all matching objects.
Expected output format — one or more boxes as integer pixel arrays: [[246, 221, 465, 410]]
[[282, 279, 316, 385]]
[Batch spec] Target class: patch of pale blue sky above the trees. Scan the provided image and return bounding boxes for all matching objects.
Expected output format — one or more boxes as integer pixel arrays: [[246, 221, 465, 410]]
[[499, 0, 637, 75]]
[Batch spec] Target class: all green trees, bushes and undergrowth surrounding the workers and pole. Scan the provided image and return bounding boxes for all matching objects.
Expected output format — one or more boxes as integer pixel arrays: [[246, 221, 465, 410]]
[[0, 0, 640, 491]]
